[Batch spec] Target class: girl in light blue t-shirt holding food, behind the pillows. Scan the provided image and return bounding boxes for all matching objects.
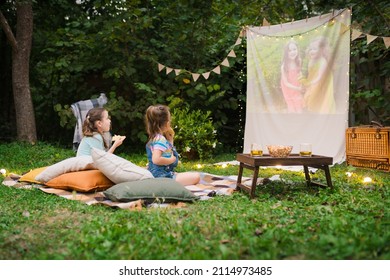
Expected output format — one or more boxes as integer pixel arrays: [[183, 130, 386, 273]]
[[76, 108, 126, 156]]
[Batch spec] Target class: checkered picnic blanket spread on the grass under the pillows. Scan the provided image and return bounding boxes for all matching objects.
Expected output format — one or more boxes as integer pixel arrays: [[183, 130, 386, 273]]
[[2, 173, 252, 210]]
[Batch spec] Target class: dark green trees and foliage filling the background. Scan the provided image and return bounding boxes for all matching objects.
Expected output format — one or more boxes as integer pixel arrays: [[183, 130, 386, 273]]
[[0, 0, 390, 153]]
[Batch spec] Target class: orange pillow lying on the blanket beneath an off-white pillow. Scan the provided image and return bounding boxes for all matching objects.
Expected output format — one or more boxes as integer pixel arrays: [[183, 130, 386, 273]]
[[45, 170, 114, 192]]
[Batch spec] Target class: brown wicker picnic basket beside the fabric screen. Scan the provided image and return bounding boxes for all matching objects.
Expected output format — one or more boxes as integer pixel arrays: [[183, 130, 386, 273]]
[[345, 122, 390, 171]]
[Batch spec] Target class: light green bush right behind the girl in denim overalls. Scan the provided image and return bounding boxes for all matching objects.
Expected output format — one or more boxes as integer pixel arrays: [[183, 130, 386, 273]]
[[172, 108, 217, 159]]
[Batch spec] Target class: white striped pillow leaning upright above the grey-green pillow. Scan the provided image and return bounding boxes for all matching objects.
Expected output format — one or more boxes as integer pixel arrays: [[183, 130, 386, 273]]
[[92, 148, 154, 184]]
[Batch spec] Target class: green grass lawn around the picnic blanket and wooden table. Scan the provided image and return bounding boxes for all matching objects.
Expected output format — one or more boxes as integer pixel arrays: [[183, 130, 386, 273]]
[[0, 143, 390, 260]]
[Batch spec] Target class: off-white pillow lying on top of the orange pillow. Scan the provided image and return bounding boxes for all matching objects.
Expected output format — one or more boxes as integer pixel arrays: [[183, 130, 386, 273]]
[[35, 156, 96, 183]]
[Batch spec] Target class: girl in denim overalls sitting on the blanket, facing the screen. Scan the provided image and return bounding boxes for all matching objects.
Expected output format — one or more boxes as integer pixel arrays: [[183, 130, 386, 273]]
[[145, 105, 200, 186]]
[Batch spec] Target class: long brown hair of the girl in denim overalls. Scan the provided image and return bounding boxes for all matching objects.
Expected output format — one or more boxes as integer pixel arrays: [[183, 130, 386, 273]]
[[145, 104, 171, 140]]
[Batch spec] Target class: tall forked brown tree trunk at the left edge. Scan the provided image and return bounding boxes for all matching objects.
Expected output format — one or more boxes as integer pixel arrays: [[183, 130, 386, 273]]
[[0, 1, 37, 144]]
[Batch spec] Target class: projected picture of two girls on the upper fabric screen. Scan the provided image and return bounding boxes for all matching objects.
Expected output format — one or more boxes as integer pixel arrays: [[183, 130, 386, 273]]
[[247, 10, 349, 114]]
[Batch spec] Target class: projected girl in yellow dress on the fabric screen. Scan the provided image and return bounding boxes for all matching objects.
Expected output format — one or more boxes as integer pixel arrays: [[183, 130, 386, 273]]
[[300, 36, 336, 114]]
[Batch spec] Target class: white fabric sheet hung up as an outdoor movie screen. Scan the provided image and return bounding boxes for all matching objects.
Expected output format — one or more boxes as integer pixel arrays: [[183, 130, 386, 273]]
[[244, 10, 351, 163]]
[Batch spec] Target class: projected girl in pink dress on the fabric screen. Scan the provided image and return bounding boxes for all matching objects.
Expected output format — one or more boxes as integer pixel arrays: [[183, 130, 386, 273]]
[[280, 40, 303, 113]]
